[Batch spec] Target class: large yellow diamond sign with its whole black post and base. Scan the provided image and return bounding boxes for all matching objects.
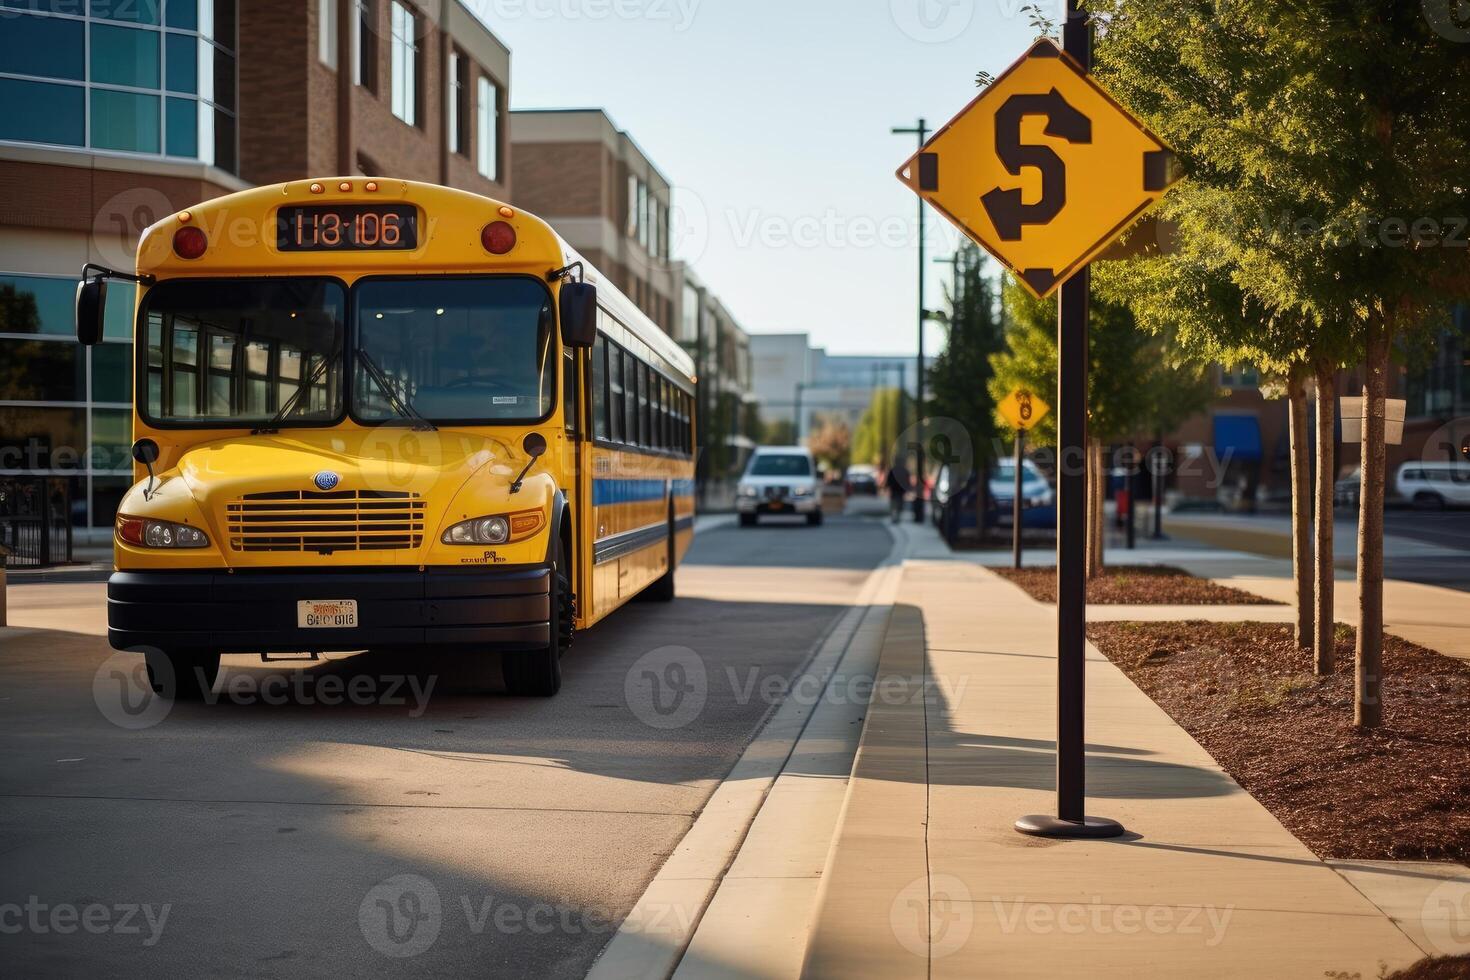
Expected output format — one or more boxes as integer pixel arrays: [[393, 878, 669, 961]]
[[898, 0, 1179, 837]]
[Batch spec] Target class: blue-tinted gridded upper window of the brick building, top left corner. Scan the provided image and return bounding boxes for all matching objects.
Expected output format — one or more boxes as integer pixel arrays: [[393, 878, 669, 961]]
[[0, 0, 237, 172]]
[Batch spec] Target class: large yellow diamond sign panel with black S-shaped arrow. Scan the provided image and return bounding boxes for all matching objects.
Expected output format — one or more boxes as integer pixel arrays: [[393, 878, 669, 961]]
[[898, 40, 1176, 297]]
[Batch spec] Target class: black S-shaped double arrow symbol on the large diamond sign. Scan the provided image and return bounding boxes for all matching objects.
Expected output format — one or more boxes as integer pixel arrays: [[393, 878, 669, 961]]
[[980, 88, 1092, 241]]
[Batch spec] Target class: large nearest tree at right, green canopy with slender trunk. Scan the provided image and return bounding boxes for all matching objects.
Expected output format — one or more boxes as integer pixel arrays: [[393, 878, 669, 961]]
[[1091, 0, 1470, 727]]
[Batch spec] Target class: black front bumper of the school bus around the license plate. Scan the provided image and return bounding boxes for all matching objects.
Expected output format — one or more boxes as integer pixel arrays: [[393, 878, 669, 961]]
[[107, 566, 551, 654]]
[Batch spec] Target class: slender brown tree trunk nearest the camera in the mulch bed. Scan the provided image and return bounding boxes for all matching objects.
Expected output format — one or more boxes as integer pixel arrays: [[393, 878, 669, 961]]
[[1354, 316, 1389, 729]]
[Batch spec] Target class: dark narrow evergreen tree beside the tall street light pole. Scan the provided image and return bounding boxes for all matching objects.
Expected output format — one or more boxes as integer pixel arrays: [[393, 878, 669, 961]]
[[929, 244, 1005, 467]]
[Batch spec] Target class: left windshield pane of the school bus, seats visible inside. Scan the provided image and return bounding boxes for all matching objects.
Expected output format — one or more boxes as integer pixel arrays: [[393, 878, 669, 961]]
[[138, 279, 347, 428]]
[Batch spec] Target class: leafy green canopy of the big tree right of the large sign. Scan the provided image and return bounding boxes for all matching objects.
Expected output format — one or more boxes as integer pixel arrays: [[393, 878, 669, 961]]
[[1089, 0, 1470, 359]]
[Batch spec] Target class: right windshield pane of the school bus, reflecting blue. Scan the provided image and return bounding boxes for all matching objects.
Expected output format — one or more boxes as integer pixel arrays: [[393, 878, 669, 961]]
[[353, 276, 556, 425]]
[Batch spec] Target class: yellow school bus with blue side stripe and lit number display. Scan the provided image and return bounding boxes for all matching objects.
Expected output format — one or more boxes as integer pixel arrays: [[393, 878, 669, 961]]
[[76, 176, 695, 698]]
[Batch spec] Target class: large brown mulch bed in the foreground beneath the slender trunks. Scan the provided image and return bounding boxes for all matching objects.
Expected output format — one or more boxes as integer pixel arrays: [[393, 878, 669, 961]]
[[1088, 623, 1470, 863]]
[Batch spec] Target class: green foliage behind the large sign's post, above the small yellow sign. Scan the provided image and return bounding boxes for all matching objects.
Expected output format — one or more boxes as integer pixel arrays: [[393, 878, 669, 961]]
[[989, 276, 1216, 445]]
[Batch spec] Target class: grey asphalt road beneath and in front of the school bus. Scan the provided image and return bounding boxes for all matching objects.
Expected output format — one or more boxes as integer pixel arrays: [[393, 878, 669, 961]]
[[0, 519, 889, 979]]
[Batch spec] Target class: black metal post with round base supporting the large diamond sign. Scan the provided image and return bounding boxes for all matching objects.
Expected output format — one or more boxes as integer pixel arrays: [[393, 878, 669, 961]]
[[1016, 0, 1123, 837]]
